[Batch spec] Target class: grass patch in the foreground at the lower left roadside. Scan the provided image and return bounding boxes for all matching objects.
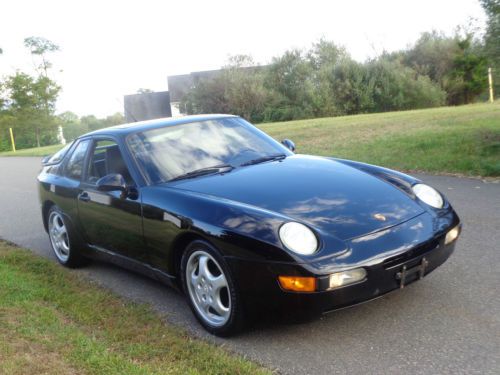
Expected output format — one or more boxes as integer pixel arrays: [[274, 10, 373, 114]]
[[0, 241, 270, 374]]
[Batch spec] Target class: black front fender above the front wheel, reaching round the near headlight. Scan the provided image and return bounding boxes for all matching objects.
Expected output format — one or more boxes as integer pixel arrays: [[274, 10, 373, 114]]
[[138, 186, 347, 271]]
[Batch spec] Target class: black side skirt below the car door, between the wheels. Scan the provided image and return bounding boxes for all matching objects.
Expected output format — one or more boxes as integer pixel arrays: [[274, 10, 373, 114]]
[[85, 245, 179, 290]]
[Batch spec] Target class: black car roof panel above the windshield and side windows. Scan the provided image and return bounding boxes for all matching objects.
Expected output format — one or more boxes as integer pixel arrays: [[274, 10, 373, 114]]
[[80, 114, 237, 138]]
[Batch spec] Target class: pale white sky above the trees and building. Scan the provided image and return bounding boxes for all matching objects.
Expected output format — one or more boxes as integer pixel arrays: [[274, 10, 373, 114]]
[[0, 0, 485, 117]]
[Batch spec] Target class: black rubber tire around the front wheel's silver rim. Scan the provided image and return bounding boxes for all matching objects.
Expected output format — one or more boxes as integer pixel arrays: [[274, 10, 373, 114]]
[[180, 240, 245, 337]]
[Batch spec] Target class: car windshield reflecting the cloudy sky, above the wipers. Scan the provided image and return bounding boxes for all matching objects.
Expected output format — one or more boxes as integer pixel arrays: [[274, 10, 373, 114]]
[[127, 117, 291, 184]]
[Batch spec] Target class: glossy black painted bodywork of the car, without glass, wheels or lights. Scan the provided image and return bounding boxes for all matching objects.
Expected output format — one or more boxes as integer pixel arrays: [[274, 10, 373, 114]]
[[38, 116, 460, 318]]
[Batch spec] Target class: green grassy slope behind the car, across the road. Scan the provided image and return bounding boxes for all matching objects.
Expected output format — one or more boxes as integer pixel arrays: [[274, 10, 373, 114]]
[[0, 101, 500, 176]]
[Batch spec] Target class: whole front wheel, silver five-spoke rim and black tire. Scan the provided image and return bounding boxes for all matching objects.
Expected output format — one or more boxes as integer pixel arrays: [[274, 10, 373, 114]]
[[181, 241, 243, 336]]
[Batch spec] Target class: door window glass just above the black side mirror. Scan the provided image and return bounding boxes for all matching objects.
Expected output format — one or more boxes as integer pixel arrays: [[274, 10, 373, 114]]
[[87, 139, 133, 185]]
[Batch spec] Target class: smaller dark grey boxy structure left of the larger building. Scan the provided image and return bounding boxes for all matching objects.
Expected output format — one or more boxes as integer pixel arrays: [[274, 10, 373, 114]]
[[124, 91, 172, 122]]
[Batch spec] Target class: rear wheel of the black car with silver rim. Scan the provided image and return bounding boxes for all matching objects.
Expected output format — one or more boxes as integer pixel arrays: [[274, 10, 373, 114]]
[[47, 205, 88, 268]]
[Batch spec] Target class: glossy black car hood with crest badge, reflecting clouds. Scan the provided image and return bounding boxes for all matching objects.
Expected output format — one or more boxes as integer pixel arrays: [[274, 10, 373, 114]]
[[166, 155, 424, 240]]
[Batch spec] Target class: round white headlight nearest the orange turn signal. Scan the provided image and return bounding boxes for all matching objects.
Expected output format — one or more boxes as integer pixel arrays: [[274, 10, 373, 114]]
[[279, 221, 318, 255]]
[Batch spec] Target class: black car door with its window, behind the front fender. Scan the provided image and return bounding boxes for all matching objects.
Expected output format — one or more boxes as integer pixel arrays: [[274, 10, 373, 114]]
[[78, 138, 147, 262]]
